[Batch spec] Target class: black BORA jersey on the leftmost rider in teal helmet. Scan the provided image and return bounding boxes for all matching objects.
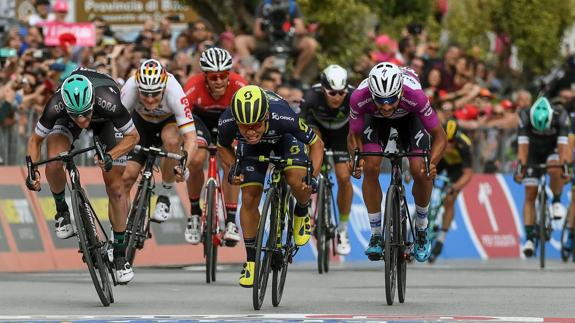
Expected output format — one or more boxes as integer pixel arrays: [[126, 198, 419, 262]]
[[35, 68, 135, 137]]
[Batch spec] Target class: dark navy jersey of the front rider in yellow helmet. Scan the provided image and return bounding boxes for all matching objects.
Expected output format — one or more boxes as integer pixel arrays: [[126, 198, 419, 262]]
[[218, 92, 317, 147]]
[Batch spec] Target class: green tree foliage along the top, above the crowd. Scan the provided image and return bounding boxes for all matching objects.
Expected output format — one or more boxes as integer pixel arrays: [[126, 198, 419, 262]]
[[187, 0, 575, 78]]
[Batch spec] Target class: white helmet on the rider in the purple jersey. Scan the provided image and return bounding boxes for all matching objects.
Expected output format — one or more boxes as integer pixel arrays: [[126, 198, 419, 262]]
[[368, 62, 403, 104]]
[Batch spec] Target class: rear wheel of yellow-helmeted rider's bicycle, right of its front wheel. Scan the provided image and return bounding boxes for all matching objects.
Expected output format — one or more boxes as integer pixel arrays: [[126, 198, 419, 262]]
[[272, 189, 295, 307]]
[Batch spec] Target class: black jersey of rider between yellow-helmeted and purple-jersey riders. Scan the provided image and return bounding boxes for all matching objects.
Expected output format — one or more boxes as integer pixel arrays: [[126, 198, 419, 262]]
[[300, 83, 355, 130]]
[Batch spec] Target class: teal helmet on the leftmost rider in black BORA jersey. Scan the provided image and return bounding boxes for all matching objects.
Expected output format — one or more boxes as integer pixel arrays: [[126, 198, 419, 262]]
[[60, 74, 94, 113]]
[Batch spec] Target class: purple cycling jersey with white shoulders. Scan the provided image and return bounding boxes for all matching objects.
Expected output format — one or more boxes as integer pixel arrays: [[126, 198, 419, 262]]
[[349, 70, 439, 134]]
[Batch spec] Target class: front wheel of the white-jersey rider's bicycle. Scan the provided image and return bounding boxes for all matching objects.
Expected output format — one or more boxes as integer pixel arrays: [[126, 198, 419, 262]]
[[126, 179, 150, 265]]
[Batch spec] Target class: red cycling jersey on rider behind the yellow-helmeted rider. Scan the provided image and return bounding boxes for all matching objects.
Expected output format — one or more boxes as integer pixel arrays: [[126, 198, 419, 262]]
[[184, 72, 248, 111]]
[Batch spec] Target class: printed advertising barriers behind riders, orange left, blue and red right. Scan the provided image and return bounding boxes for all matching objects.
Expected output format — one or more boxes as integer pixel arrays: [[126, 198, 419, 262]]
[[0, 167, 570, 271]]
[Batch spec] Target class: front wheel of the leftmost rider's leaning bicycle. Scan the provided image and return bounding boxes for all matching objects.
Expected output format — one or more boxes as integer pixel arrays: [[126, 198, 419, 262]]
[[72, 190, 113, 306]]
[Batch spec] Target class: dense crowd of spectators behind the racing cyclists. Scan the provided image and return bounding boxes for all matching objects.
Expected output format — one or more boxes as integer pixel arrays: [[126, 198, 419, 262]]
[[4, 0, 575, 172]]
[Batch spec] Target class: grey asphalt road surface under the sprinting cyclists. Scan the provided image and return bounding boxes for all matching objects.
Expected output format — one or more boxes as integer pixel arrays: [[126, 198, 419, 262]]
[[0, 260, 575, 322]]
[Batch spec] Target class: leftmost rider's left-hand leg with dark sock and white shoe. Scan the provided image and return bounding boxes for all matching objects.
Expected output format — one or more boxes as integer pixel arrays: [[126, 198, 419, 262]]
[[46, 133, 74, 239]]
